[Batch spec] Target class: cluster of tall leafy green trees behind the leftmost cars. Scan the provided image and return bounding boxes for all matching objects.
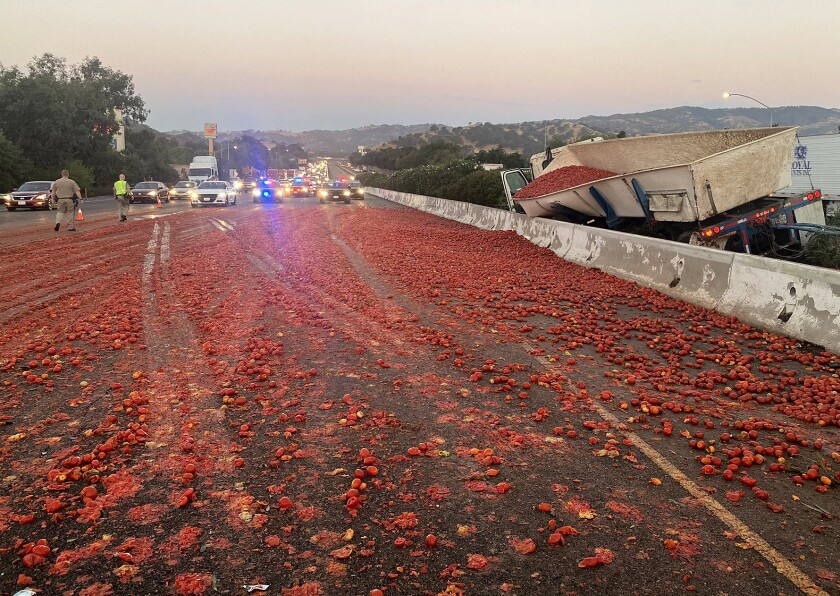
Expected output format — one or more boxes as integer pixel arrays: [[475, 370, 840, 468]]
[[0, 54, 178, 193]]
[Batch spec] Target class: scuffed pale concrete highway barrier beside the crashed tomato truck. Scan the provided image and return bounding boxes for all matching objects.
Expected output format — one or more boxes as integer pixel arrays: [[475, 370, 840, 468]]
[[366, 188, 840, 354]]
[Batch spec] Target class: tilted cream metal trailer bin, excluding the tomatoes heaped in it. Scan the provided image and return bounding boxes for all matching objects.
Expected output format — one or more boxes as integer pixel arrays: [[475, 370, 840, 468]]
[[514, 126, 796, 222]]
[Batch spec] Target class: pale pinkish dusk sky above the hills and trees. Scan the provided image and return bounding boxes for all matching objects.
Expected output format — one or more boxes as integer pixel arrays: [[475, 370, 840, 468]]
[[0, 0, 840, 131]]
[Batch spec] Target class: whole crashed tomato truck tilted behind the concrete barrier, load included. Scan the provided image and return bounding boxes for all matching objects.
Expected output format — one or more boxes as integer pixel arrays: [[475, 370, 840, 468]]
[[502, 127, 840, 256]]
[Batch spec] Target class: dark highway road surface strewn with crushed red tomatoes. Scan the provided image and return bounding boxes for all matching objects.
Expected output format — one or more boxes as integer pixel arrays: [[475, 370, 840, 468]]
[[0, 195, 840, 596]]
